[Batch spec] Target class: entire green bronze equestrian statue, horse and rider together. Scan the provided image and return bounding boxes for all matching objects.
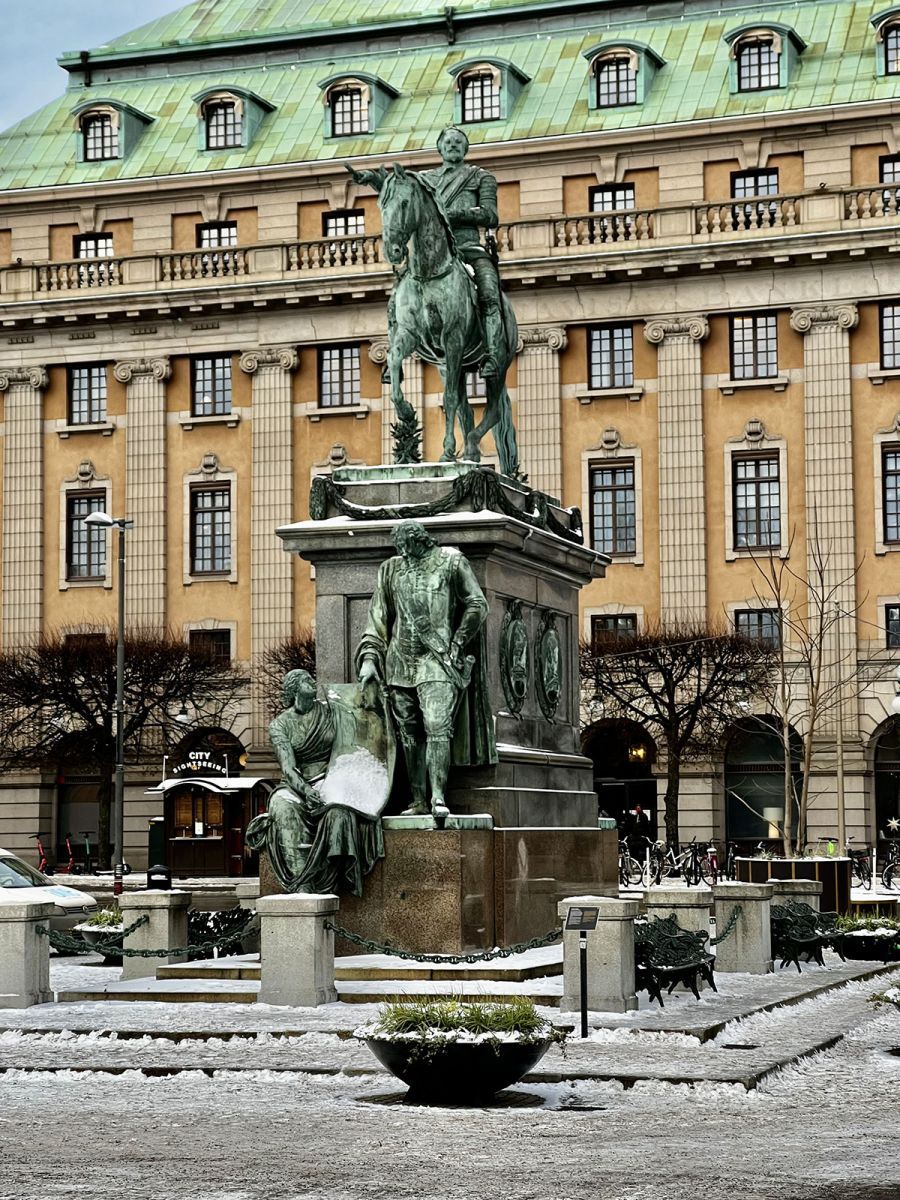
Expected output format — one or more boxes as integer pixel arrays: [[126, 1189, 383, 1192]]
[[348, 127, 520, 478]]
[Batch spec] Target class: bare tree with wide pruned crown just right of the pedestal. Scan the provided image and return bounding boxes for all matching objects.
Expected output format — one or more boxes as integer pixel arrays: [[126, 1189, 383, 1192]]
[[581, 624, 773, 846]]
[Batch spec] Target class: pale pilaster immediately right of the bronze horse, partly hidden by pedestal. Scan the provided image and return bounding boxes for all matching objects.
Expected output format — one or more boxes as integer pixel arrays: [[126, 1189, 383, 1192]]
[[516, 325, 568, 497]]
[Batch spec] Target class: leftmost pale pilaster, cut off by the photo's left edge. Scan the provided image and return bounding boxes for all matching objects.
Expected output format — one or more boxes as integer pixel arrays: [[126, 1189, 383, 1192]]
[[0, 366, 49, 649]]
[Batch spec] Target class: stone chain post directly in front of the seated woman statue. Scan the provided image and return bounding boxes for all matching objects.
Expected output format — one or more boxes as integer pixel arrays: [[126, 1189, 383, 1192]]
[[257, 894, 340, 1008]]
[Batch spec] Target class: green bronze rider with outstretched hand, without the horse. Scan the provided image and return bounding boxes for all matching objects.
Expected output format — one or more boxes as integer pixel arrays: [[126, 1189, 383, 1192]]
[[347, 125, 503, 379]]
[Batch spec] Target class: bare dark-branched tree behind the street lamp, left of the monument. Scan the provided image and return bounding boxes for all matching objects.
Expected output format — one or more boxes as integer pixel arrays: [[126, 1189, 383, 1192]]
[[0, 626, 247, 865]]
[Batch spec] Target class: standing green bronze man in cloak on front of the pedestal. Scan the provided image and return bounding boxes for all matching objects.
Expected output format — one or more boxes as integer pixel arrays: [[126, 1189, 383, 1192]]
[[356, 521, 497, 818]]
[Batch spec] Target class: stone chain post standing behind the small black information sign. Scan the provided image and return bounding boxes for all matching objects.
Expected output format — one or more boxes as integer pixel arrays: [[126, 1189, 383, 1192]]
[[557, 896, 641, 1013]]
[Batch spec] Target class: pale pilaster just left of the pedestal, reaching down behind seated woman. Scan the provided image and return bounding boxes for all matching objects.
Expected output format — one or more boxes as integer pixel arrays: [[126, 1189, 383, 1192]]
[[240, 346, 298, 744]]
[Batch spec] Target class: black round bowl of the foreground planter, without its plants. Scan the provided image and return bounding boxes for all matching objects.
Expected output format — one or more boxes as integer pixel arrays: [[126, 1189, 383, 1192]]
[[366, 1038, 550, 1104]]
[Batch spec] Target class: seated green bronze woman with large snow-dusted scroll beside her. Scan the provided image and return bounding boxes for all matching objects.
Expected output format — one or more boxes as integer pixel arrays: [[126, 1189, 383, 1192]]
[[247, 671, 395, 896]]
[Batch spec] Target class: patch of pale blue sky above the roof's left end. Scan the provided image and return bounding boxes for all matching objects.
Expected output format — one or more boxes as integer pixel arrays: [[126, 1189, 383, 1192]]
[[0, 0, 188, 130]]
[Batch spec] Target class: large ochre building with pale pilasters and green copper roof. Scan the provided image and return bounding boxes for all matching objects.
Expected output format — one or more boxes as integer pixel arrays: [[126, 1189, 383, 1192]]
[[0, 0, 900, 863]]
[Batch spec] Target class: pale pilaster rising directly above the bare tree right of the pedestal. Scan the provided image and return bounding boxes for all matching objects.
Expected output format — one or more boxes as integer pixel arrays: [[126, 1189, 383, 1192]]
[[644, 316, 709, 623]]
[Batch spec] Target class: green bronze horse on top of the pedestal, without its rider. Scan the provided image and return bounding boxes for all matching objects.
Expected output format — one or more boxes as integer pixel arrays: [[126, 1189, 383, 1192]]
[[352, 163, 521, 479]]
